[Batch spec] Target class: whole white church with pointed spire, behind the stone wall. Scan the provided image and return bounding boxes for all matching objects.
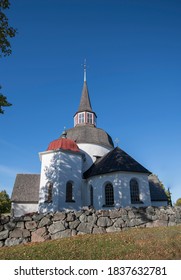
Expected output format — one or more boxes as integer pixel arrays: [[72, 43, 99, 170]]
[[11, 65, 168, 217]]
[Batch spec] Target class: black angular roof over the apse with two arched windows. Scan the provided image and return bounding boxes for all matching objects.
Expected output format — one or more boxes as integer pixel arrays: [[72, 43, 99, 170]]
[[84, 147, 151, 178]]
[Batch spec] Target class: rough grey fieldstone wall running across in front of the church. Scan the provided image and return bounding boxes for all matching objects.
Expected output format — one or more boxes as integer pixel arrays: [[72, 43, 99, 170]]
[[0, 206, 181, 247]]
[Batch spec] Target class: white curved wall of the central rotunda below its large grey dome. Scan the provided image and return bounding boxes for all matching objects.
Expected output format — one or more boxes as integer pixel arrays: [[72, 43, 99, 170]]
[[78, 143, 111, 172]]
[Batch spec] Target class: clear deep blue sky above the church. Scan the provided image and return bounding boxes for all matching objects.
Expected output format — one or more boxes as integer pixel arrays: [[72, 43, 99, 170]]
[[0, 0, 181, 202]]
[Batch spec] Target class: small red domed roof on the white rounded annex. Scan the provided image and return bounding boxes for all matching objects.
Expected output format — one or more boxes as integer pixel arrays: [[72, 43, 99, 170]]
[[47, 138, 80, 152]]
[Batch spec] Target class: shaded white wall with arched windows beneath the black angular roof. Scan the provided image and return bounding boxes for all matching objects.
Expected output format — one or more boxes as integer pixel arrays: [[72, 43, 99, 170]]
[[87, 172, 151, 209]]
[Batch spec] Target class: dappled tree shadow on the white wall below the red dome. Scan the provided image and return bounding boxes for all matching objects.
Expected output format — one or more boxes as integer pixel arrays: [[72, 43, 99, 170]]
[[39, 152, 82, 212]]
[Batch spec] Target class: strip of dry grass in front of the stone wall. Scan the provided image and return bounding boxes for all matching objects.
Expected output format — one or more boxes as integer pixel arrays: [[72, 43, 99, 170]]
[[0, 226, 181, 260]]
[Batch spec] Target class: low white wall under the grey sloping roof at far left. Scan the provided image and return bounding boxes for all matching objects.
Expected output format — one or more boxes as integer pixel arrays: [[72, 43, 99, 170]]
[[11, 202, 38, 217]]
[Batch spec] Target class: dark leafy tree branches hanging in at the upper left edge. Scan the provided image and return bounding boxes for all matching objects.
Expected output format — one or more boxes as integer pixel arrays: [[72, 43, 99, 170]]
[[0, 0, 17, 114]]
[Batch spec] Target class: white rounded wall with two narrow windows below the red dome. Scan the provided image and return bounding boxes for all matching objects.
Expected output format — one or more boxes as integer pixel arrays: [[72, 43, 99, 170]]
[[39, 151, 82, 213]]
